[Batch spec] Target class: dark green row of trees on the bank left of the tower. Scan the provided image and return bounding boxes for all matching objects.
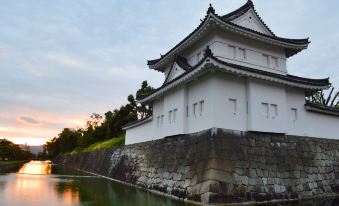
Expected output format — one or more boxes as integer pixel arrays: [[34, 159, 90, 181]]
[[38, 81, 154, 159]]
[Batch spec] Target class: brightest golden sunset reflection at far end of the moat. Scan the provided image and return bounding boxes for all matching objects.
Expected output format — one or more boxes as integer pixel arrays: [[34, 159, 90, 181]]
[[19, 161, 52, 175]]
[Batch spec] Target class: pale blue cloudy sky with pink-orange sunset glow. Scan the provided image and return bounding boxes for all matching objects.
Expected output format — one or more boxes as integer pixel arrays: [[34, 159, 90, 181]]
[[0, 0, 339, 145]]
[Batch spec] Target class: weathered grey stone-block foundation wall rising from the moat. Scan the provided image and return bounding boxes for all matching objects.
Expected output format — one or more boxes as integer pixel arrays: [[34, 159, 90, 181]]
[[56, 128, 339, 203]]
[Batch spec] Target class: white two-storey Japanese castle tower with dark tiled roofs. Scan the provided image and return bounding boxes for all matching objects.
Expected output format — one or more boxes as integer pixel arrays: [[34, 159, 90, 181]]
[[124, 1, 339, 144]]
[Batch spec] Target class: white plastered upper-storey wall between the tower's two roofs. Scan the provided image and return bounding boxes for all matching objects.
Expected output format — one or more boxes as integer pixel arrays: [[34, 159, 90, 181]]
[[181, 31, 287, 74]]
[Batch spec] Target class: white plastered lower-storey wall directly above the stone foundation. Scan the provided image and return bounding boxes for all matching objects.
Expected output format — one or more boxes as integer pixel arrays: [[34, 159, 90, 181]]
[[126, 72, 339, 144]]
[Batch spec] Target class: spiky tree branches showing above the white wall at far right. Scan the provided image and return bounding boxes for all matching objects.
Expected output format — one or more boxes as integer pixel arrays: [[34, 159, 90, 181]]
[[306, 87, 339, 107]]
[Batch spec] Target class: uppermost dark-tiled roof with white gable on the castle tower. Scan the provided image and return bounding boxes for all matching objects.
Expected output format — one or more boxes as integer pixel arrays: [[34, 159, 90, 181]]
[[147, 0, 310, 72]]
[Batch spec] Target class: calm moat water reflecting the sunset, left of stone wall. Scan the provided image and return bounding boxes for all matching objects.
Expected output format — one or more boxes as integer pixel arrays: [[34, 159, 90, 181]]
[[0, 161, 195, 206]]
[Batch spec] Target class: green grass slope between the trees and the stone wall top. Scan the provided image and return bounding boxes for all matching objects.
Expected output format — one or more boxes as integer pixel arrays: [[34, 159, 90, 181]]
[[68, 135, 125, 154]]
